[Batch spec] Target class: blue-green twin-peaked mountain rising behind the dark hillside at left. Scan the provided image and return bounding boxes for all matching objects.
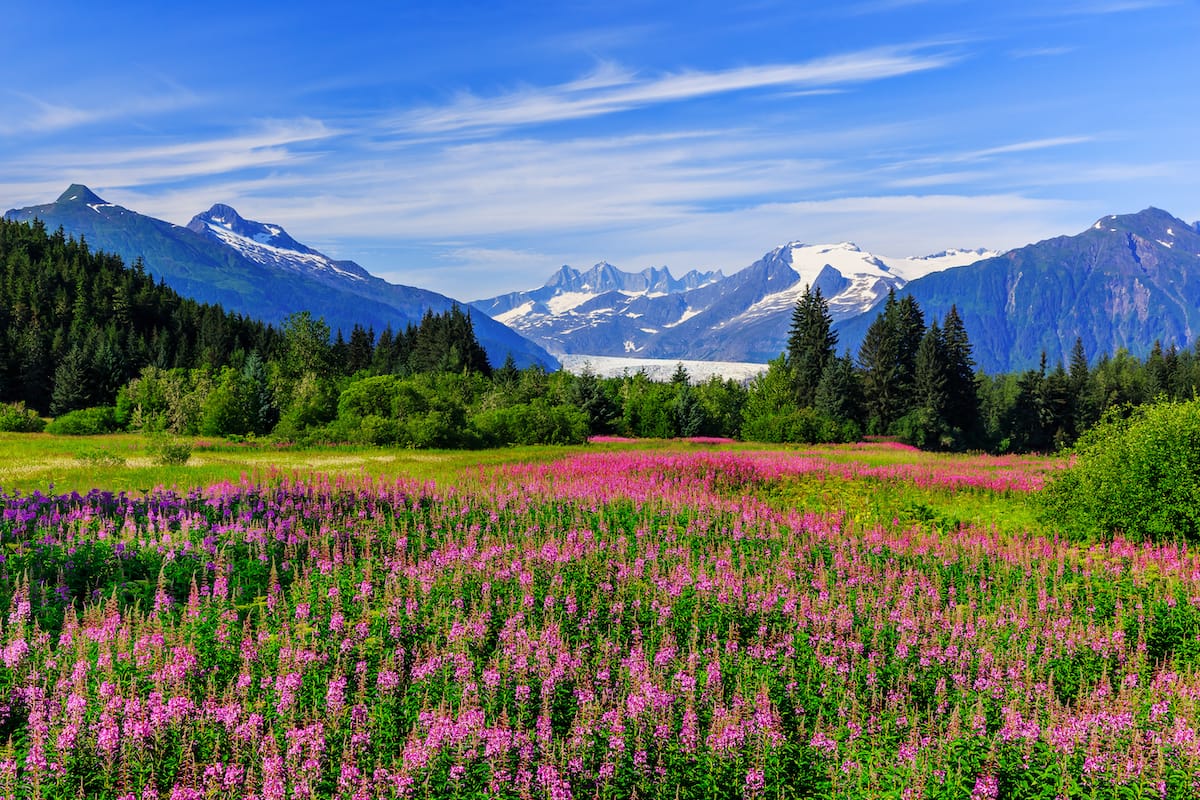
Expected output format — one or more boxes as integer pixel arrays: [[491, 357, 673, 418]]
[[5, 184, 557, 368]]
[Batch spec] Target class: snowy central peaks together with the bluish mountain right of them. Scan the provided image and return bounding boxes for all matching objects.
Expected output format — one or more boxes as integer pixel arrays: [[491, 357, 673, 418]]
[[473, 207, 1200, 374]]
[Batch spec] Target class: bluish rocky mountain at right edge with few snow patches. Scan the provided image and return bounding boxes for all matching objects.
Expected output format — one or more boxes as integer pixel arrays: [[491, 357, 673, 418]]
[[838, 207, 1200, 373]]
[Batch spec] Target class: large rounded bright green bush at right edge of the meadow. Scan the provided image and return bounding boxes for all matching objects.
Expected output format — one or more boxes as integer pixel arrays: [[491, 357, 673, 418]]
[[1042, 401, 1200, 540]]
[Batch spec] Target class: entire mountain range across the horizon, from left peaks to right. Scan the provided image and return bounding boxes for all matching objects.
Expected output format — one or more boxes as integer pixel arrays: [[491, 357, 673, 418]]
[[5, 185, 1200, 373]]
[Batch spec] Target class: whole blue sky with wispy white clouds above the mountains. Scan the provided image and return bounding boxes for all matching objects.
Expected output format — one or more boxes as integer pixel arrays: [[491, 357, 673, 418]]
[[0, 0, 1200, 300]]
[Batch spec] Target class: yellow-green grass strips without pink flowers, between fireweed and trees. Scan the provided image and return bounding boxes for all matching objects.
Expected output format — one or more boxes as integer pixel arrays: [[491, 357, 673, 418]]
[[0, 433, 1058, 531]]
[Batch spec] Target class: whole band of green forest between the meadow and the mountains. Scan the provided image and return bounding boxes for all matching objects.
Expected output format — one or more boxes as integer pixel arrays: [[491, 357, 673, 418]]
[[0, 215, 1200, 452]]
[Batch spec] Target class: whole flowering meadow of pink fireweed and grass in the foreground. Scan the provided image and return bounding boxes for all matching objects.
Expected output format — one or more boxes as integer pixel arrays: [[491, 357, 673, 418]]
[[0, 435, 1200, 800]]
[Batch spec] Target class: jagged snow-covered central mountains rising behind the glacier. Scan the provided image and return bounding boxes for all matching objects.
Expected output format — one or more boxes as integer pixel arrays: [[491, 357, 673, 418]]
[[472, 242, 994, 362]]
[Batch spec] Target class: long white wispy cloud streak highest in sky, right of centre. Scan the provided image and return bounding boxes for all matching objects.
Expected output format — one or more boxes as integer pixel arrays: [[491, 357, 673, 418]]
[[396, 48, 958, 134]]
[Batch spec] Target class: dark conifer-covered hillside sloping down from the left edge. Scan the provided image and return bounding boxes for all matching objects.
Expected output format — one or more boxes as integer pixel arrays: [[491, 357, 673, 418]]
[[0, 215, 280, 414]]
